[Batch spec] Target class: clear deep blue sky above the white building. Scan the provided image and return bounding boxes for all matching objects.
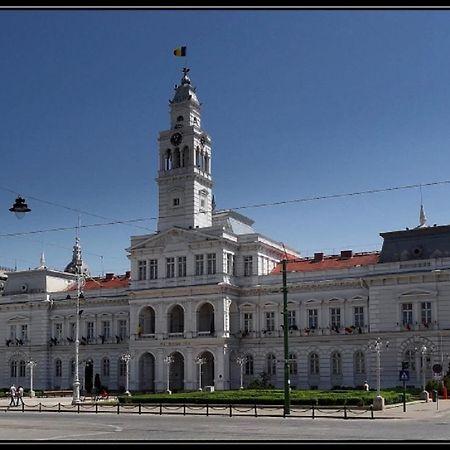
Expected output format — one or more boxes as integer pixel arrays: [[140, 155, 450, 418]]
[[0, 9, 450, 276]]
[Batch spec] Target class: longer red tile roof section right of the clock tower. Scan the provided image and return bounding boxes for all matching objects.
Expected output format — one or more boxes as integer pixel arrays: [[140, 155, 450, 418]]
[[272, 252, 380, 274]]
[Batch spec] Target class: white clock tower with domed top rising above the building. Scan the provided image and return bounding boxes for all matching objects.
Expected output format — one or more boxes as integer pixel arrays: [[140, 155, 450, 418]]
[[156, 68, 213, 232]]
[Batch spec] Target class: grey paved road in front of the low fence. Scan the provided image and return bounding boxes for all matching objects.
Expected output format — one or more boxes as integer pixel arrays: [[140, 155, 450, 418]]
[[0, 398, 450, 444]]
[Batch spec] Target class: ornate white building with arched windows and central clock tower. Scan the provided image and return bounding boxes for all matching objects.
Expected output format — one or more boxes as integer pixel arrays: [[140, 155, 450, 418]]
[[0, 69, 450, 391]]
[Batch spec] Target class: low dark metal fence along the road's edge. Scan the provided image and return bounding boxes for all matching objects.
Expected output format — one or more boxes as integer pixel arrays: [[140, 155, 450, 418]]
[[0, 402, 375, 419]]
